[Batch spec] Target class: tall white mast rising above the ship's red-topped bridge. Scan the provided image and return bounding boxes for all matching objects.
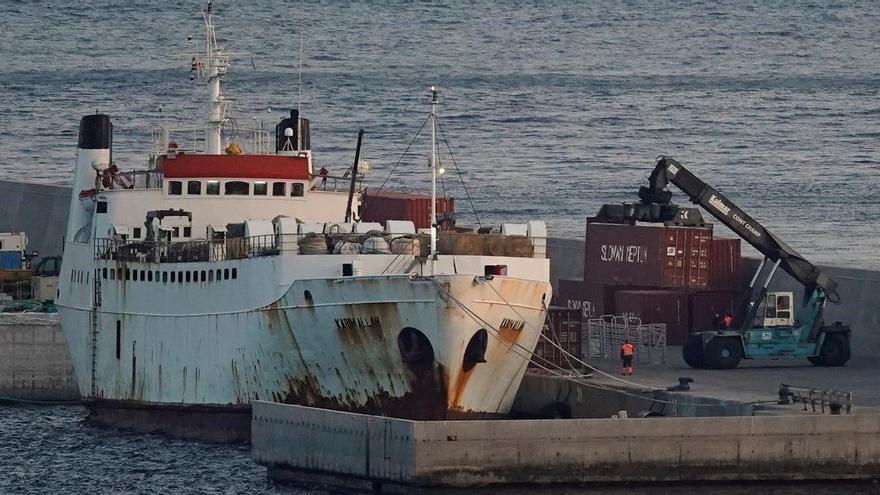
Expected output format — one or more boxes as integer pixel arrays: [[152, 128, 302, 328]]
[[200, 1, 229, 155]]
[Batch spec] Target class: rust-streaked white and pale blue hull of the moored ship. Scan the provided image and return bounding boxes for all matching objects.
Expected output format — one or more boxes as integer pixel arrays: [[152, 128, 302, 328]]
[[59, 248, 551, 430]]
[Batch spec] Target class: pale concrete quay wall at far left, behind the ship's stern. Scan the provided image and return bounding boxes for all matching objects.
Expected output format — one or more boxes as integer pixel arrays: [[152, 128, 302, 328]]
[[0, 313, 79, 401]]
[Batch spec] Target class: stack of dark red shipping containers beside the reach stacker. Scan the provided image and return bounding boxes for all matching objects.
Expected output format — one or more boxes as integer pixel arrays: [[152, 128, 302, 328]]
[[557, 222, 742, 345]]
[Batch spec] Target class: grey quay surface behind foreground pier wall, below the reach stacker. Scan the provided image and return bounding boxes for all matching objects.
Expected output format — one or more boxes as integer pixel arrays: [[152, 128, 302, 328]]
[[512, 347, 880, 422]]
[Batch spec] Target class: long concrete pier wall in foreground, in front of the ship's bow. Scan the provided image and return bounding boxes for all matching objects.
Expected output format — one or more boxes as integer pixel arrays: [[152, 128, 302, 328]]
[[252, 401, 880, 487]]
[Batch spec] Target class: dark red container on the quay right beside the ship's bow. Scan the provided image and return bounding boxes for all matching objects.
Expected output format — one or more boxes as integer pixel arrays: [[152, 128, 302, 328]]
[[529, 306, 582, 370]]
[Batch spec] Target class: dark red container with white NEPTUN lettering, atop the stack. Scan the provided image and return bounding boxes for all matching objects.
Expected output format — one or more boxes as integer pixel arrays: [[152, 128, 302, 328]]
[[584, 222, 712, 289]]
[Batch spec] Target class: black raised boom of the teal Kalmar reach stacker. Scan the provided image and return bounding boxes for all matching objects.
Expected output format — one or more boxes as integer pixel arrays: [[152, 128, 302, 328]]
[[639, 155, 838, 301]]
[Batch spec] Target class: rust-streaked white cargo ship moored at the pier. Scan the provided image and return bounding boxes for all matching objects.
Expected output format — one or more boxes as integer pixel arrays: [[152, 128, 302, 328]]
[[56, 2, 552, 440]]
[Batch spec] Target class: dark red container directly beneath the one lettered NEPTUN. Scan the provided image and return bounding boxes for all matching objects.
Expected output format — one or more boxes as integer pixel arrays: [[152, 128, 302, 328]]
[[614, 290, 690, 345]]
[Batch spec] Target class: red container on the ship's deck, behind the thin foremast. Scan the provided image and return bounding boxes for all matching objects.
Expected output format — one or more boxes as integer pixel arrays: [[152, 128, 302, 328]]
[[360, 189, 455, 229]]
